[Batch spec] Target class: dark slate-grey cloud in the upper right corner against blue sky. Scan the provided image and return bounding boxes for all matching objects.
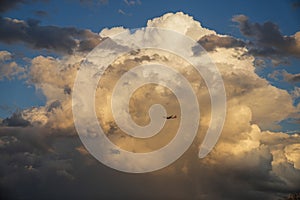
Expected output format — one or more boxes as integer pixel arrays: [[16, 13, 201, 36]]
[[232, 15, 300, 58]]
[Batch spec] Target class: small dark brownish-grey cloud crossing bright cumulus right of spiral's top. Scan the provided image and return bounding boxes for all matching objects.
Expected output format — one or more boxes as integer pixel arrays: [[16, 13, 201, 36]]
[[198, 35, 246, 51]]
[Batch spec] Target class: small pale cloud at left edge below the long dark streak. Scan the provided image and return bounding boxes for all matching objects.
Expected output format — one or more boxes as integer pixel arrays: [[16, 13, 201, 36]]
[[0, 51, 25, 81]]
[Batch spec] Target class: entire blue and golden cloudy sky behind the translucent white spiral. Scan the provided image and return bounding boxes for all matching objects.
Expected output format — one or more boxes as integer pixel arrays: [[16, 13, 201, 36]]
[[0, 0, 300, 200]]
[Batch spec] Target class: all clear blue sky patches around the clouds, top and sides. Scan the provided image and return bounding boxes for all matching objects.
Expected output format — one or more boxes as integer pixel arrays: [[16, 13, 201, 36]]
[[0, 0, 300, 131]]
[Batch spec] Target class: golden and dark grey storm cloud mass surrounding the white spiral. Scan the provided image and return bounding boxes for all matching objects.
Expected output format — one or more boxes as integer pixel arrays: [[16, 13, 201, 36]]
[[0, 12, 300, 200]]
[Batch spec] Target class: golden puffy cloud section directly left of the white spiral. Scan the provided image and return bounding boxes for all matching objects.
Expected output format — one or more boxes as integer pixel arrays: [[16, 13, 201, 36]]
[[24, 55, 83, 129]]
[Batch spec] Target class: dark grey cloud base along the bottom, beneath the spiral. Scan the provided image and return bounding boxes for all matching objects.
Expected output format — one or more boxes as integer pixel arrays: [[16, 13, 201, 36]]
[[0, 124, 300, 200]]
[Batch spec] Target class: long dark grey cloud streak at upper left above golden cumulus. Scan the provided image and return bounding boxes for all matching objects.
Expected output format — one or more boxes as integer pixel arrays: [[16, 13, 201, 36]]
[[0, 18, 101, 54]]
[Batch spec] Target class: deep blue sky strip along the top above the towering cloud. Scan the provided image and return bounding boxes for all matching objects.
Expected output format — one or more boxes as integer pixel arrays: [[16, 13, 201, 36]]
[[3, 0, 300, 36]]
